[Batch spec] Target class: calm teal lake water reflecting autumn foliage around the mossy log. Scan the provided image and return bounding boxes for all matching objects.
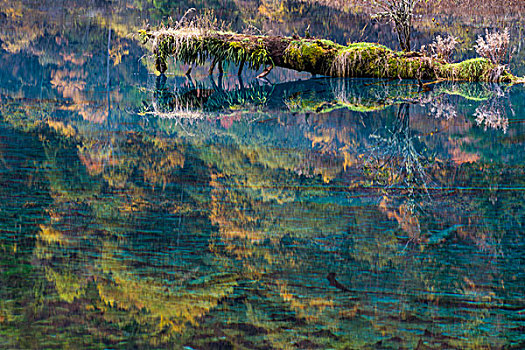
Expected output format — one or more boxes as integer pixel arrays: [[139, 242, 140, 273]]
[[0, 0, 525, 350]]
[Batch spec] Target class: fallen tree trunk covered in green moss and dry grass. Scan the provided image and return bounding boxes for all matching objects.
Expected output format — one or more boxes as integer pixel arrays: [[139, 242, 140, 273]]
[[140, 28, 518, 82]]
